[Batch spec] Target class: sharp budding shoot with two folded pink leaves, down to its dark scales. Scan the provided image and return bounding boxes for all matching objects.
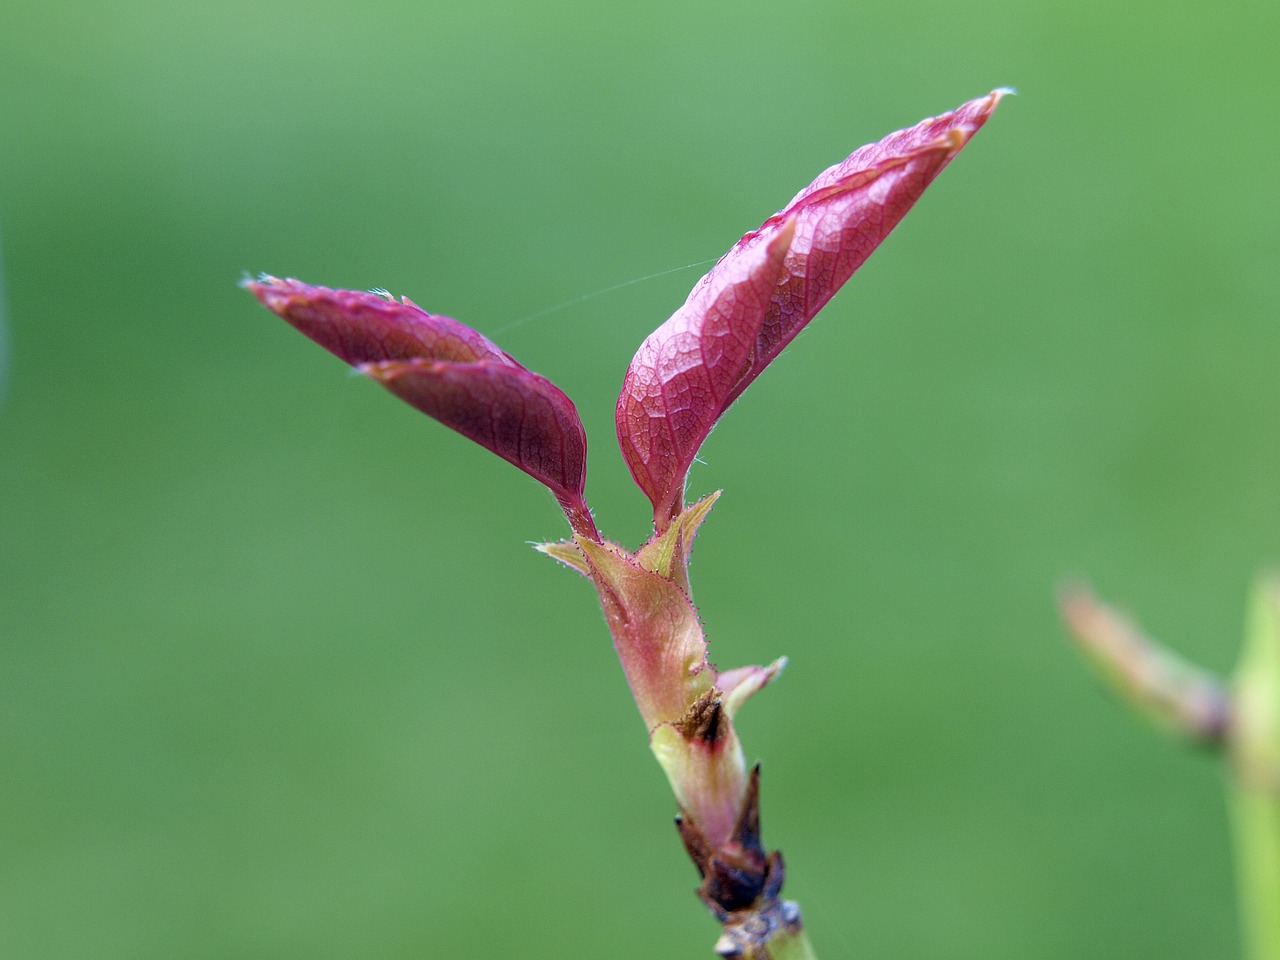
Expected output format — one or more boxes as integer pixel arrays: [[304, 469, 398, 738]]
[[247, 91, 1004, 855]]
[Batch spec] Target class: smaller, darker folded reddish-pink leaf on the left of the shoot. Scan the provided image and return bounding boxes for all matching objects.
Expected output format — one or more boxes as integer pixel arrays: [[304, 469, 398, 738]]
[[246, 278, 598, 538]]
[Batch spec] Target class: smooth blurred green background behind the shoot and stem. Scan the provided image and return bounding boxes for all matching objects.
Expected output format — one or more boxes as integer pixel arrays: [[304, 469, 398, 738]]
[[0, 0, 1280, 960]]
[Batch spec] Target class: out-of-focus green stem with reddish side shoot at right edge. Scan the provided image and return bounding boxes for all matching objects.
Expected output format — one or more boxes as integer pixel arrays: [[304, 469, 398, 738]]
[[1061, 576, 1280, 960]]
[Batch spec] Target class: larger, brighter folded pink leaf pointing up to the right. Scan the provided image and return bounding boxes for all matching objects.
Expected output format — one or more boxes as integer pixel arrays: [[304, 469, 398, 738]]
[[617, 91, 1005, 530]]
